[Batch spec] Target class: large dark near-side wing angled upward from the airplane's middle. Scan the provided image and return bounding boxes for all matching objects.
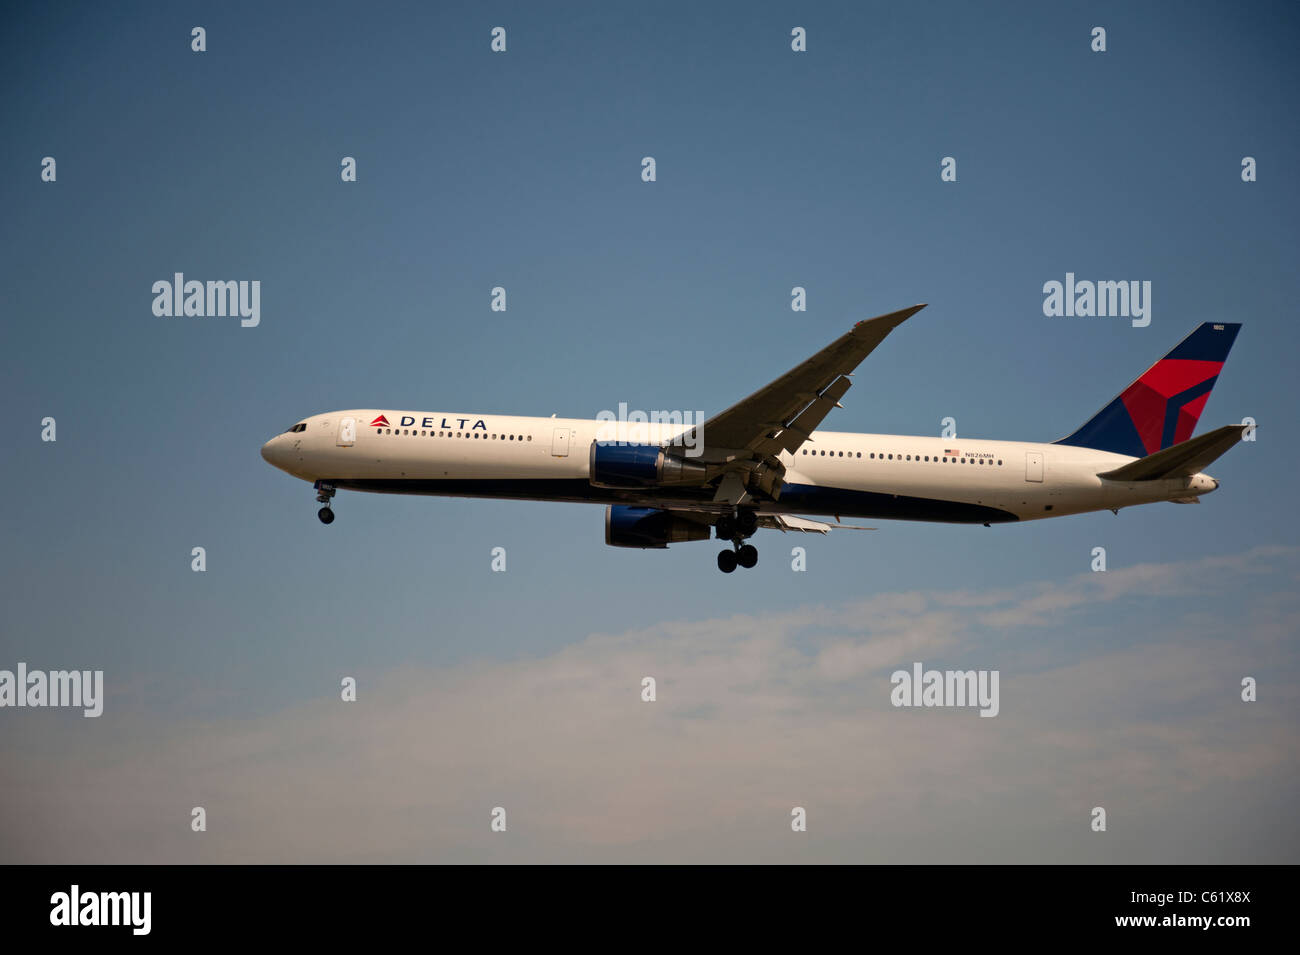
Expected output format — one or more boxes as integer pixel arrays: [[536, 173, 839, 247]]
[[672, 305, 924, 460]]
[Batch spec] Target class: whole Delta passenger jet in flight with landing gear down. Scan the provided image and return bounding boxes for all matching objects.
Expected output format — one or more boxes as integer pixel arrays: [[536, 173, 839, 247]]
[[261, 305, 1249, 573]]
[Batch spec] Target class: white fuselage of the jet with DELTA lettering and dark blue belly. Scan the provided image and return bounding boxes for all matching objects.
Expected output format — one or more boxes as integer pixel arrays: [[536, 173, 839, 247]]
[[263, 409, 1218, 524]]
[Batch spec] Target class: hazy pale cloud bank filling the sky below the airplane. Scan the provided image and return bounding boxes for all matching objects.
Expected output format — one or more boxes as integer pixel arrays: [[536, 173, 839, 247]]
[[0, 548, 1300, 863]]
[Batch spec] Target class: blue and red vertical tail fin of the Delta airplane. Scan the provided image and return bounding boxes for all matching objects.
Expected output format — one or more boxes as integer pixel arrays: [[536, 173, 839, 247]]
[[1053, 322, 1242, 457]]
